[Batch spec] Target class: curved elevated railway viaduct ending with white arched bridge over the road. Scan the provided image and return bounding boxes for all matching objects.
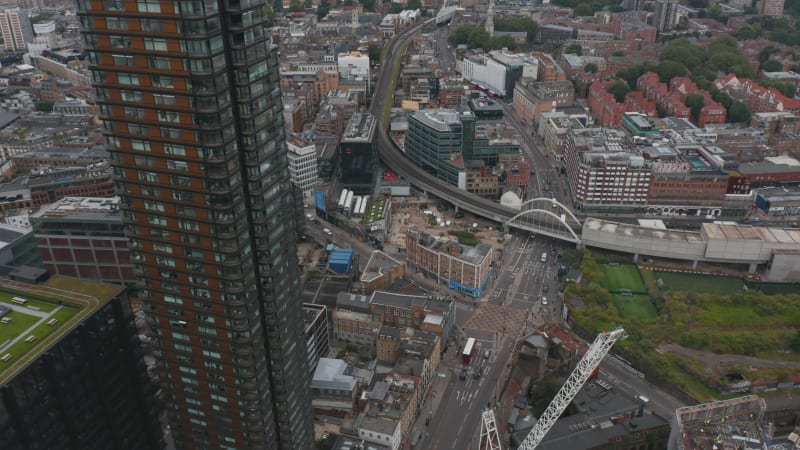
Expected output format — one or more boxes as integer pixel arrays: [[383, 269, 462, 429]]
[[370, 18, 581, 243]]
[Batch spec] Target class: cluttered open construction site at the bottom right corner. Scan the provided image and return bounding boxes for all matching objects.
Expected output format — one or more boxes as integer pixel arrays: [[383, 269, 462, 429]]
[[668, 395, 768, 450]]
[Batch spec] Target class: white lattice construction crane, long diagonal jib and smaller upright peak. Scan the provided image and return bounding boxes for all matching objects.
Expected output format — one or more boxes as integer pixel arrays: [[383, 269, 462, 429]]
[[478, 327, 628, 450]]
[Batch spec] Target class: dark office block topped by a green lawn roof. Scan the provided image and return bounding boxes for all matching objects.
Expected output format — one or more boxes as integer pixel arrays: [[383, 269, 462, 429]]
[[0, 277, 164, 450]]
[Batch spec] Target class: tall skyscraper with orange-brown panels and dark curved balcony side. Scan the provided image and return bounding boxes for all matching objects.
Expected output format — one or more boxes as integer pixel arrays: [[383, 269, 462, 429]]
[[78, 0, 313, 450]]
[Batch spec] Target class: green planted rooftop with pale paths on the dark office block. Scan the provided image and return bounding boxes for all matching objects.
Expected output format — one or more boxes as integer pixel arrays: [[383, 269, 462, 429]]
[[0, 276, 123, 386]]
